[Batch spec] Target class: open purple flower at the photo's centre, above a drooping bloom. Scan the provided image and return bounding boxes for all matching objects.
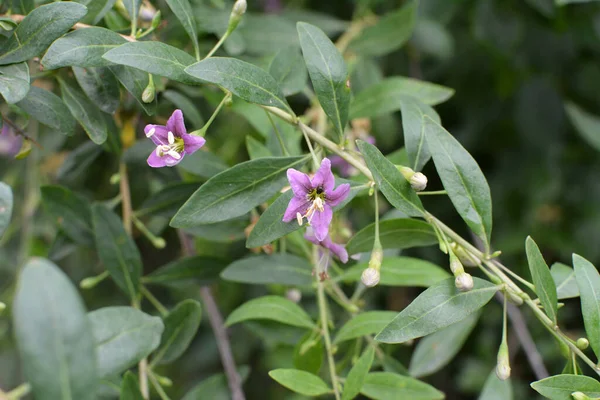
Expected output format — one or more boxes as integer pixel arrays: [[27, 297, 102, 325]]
[[283, 158, 350, 241]]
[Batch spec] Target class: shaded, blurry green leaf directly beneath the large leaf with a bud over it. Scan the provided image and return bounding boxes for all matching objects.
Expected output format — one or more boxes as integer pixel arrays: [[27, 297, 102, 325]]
[[409, 313, 479, 378]]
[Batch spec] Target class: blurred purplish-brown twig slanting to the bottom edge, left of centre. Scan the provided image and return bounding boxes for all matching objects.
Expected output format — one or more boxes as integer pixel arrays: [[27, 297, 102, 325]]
[[177, 230, 245, 400]]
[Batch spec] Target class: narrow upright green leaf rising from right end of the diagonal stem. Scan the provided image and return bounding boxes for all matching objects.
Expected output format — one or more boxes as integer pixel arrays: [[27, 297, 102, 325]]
[[525, 236, 556, 324]]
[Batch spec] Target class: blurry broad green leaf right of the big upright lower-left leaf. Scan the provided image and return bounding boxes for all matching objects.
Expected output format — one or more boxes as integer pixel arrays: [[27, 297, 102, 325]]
[[88, 307, 164, 377]]
